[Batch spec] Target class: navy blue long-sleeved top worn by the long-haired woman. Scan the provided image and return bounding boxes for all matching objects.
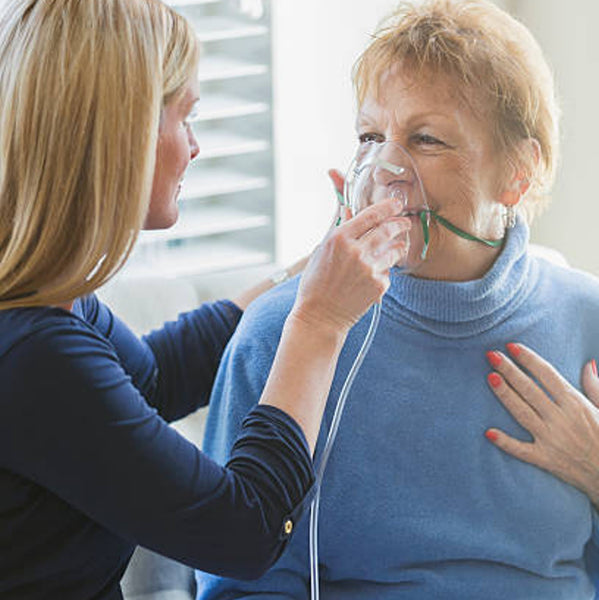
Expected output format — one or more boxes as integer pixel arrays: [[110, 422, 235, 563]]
[[0, 295, 313, 600]]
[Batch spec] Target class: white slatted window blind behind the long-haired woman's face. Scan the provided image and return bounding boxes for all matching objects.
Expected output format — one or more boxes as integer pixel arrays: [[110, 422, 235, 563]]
[[123, 0, 275, 278]]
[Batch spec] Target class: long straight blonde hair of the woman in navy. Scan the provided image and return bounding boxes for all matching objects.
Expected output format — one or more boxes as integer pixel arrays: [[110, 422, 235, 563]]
[[0, 0, 198, 309]]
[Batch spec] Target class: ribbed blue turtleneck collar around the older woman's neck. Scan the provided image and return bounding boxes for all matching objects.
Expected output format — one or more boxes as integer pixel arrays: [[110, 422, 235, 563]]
[[383, 217, 534, 338]]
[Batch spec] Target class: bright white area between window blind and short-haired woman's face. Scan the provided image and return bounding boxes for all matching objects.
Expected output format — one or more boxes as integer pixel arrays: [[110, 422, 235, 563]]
[[273, 0, 404, 263]]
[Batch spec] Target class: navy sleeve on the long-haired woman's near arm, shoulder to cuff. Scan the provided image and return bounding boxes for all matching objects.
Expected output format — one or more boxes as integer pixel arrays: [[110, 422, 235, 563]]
[[0, 323, 313, 578]]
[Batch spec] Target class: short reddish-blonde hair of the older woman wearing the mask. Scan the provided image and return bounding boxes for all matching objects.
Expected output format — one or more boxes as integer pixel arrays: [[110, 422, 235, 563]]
[[353, 0, 559, 219]]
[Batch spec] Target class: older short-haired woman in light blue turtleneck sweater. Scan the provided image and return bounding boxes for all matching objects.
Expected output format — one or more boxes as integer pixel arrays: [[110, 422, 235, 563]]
[[197, 0, 599, 600]]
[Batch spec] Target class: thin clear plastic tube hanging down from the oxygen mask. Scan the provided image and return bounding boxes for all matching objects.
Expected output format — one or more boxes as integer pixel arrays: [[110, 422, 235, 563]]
[[310, 303, 381, 600]]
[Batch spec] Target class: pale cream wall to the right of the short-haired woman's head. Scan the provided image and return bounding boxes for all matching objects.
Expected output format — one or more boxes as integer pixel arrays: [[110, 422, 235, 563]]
[[511, 0, 599, 275]]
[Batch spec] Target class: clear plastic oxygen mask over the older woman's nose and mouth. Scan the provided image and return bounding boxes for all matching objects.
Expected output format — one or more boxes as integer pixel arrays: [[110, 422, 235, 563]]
[[344, 141, 430, 272]]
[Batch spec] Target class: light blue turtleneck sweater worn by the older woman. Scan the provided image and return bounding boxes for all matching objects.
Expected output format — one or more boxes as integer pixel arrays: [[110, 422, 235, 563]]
[[197, 217, 599, 600]]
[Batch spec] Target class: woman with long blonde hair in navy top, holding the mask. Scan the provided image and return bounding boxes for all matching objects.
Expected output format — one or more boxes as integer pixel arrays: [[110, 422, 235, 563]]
[[0, 0, 406, 600]]
